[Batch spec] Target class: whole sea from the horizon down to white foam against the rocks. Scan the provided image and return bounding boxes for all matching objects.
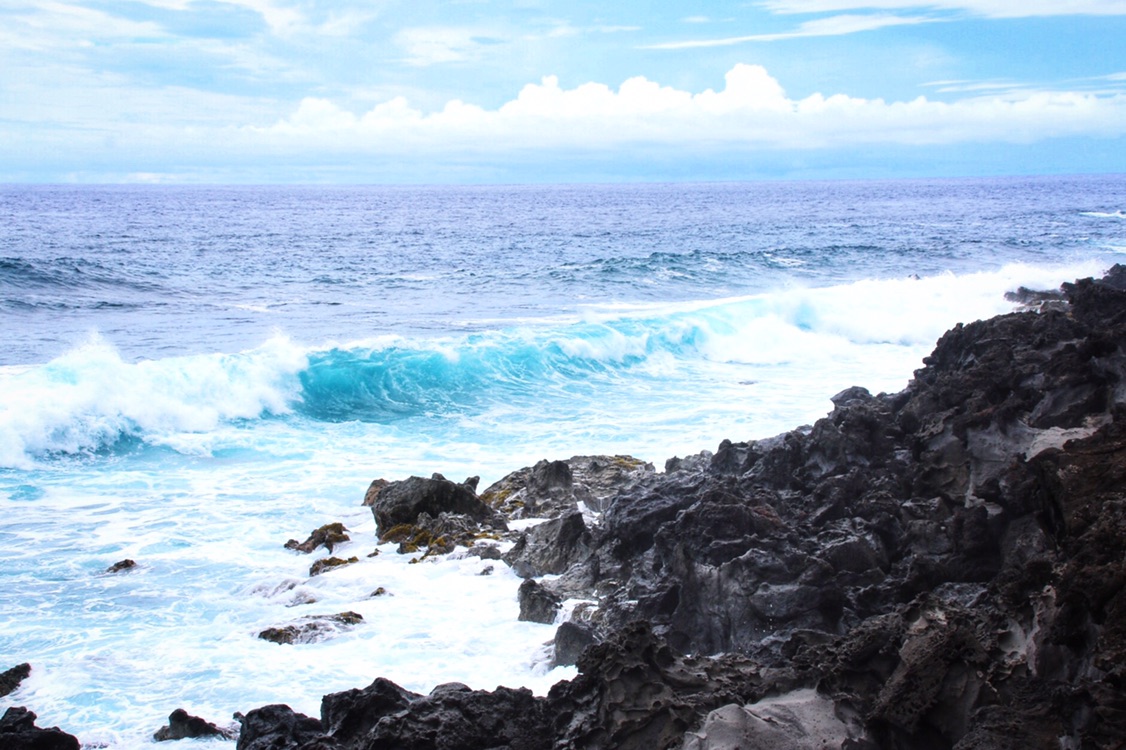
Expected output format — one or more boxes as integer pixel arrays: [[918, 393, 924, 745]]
[[0, 177, 1126, 749]]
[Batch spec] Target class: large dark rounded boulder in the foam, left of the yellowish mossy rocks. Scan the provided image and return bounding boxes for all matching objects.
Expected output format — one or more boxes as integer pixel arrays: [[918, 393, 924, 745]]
[[372, 474, 503, 531]]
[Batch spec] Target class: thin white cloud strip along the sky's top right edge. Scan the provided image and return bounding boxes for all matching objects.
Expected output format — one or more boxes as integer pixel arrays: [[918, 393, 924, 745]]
[[757, 0, 1126, 18]]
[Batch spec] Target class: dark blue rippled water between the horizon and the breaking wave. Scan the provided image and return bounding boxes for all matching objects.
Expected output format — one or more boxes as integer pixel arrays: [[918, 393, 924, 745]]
[[0, 177, 1126, 364]]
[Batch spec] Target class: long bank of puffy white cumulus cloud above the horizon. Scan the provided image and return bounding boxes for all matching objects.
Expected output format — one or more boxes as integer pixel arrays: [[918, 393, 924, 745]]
[[252, 64, 1126, 153]]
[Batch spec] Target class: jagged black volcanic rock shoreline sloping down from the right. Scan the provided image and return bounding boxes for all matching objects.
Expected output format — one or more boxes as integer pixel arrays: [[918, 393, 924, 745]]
[[8, 266, 1126, 750]]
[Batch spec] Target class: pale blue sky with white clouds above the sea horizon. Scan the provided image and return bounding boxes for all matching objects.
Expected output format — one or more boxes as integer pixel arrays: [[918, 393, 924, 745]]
[[0, 0, 1126, 184]]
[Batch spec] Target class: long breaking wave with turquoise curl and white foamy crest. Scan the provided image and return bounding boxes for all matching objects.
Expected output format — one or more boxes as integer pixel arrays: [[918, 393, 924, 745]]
[[0, 260, 1098, 466]]
